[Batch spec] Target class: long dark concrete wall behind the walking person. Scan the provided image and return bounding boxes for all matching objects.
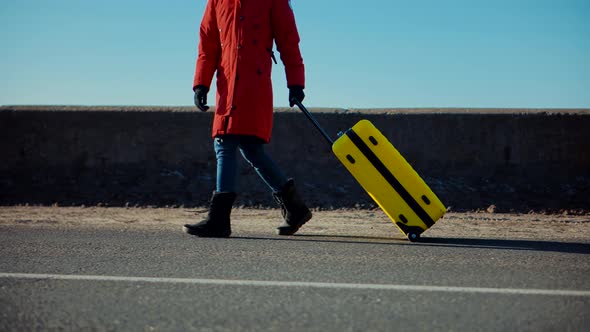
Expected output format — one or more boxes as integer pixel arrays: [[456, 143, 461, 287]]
[[0, 106, 590, 212]]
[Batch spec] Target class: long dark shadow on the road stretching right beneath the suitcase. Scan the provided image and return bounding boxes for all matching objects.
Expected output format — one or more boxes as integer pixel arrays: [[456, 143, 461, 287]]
[[237, 234, 590, 254]]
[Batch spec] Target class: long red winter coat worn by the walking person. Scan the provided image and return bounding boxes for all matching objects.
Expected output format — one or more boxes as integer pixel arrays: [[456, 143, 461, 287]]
[[193, 0, 305, 142]]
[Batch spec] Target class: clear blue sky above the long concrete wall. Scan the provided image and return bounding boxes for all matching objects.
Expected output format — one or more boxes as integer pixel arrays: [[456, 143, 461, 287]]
[[0, 0, 590, 108]]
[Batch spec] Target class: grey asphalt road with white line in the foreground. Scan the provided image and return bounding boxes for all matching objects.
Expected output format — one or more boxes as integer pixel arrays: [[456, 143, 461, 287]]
[[0, 219, 590, 331]]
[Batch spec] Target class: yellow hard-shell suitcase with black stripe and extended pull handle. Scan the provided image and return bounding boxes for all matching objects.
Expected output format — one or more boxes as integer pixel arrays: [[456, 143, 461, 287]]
[[295, 102, 447, 242]]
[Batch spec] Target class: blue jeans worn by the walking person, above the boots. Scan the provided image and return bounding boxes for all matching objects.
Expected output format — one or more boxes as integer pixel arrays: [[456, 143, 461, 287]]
[[214, 135, 287, 192]]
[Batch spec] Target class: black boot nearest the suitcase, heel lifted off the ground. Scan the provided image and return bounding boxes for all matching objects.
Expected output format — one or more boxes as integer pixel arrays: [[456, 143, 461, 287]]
[[273, 179, 311, 235]]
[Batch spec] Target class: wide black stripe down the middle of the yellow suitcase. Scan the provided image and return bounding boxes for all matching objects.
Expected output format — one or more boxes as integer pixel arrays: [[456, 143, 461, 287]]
[[346, 128, 434, 227]]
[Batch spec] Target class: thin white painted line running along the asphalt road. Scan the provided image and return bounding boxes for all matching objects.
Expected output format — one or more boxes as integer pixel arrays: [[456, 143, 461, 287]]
[[0, 273, 590, 297]]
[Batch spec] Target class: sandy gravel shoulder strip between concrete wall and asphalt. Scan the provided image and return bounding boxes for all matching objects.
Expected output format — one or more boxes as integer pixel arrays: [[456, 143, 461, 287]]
[[0, 206, 590, 242]]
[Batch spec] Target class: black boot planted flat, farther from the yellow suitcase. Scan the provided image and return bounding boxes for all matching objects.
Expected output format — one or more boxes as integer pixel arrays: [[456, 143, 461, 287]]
[[184, 192, 236, 237]]
